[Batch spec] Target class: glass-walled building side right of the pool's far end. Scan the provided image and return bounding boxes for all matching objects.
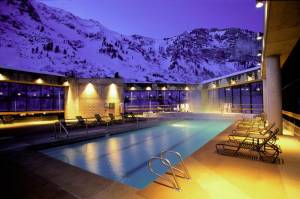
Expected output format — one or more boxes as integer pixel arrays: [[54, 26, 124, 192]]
[[201, 67, 263, 114]]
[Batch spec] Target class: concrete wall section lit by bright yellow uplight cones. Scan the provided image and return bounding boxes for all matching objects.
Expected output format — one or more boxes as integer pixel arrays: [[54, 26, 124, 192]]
[[65, 78, 124, 119]]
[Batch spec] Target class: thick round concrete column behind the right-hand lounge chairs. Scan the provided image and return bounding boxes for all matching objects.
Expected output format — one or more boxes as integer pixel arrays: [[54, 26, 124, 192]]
[[265, 56, 282, 133]]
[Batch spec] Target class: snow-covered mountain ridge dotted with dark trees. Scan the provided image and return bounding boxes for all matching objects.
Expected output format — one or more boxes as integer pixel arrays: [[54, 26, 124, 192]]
[[0, 0, 261, 83]]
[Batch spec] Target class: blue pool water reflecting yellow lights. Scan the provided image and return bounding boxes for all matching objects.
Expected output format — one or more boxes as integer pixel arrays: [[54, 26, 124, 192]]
[[41, 120, 232, 188]]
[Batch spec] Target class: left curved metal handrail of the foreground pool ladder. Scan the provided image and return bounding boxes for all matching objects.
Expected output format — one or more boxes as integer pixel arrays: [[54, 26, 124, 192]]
[[148, 157, 181, 191]]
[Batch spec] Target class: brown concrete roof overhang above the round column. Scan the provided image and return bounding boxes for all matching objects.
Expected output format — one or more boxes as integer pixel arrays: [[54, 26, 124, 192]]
[[262, 1, 300, 78]]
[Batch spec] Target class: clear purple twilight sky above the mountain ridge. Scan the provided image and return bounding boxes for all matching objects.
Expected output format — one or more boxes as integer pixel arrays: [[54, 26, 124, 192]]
[[40, 0, 264, 38]]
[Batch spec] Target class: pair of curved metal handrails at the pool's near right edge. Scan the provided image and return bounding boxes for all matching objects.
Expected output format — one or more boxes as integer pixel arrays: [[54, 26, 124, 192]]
[[148, 151, 191, 191]]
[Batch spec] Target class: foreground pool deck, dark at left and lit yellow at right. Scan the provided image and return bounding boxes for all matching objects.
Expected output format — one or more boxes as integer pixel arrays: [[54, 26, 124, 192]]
[[0, 121, 300, 199]]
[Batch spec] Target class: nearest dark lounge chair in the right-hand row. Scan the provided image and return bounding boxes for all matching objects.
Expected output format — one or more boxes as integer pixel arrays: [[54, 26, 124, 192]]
[[216, 129, 281, 162]]
